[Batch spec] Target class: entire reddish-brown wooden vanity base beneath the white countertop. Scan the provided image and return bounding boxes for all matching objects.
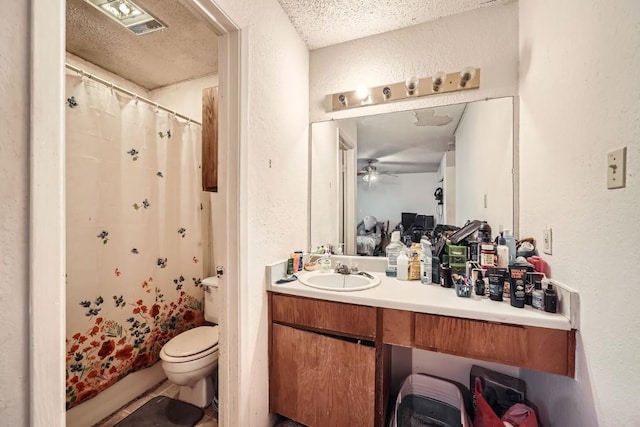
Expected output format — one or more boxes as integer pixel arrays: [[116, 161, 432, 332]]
[[268, 292, 575, 427]]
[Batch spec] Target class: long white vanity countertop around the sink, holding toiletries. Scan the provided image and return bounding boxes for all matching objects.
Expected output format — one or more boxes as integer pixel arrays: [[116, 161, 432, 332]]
[[267, 263, 574, 330]]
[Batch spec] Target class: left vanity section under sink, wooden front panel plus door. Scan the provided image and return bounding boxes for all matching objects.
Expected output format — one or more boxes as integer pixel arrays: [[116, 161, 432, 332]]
[[269, 294, 381, 427]]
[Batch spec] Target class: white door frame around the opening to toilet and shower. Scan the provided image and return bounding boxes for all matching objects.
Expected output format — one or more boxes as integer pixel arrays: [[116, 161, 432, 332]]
[[29, 0, 248, 427]]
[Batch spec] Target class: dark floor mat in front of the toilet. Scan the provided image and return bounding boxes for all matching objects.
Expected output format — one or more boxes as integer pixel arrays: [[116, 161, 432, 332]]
[[114, 396, 204, 427]]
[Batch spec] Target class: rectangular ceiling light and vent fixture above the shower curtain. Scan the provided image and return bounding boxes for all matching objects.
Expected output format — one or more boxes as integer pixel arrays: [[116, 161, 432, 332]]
[[85, 0, 167, 35]]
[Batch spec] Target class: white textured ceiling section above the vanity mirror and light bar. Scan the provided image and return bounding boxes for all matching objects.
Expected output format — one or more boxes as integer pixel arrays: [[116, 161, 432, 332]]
[[278, 0, 509, 50]]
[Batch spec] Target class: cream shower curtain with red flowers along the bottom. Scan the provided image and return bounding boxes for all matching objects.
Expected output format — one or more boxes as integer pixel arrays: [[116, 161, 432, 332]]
[[66, 75, 205, 409]]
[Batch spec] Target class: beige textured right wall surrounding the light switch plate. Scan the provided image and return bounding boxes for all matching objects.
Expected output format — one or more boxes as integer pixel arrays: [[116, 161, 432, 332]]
[[519, 0, 640, 427]]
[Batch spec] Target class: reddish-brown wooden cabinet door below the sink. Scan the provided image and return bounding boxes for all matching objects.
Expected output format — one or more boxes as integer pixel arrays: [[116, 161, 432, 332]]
[[269, 324, 376, 427]]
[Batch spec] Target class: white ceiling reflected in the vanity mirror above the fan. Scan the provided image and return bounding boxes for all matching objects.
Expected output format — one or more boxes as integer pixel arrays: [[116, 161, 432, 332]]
[[356, 104, 466, 174]]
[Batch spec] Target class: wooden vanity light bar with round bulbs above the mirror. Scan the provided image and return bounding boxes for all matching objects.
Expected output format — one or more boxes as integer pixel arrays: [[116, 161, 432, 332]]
[[331, 67, 480, 111]]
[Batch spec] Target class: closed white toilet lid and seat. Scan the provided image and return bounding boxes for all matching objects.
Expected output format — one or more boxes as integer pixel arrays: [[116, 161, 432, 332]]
[[160, 326, 218, 363]]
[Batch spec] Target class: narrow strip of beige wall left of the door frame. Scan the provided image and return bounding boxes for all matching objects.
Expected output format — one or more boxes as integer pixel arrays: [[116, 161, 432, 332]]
[[0, 1, 29, 426]]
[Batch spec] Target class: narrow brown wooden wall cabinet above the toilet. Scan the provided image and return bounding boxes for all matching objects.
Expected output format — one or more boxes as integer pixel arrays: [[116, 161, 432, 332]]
[[202, 87, 218, 192]]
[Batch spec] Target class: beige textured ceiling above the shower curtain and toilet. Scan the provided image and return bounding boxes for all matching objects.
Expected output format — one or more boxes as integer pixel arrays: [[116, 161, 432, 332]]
[[67, 0, 218, 90]]
